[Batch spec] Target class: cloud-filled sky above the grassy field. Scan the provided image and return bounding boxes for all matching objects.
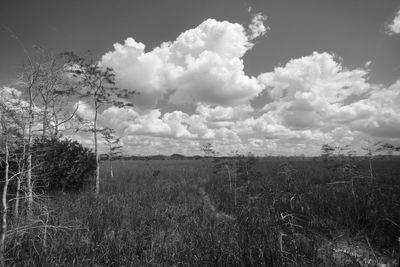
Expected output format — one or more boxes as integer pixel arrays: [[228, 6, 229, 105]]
[[0, 0, 400, 155]]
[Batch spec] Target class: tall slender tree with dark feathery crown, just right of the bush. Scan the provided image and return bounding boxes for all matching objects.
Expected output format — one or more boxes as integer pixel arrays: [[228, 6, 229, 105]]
[[64, 52, 135, 194]]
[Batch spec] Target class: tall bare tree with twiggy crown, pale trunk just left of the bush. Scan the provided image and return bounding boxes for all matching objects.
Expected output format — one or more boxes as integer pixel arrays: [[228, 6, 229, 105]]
[[20, 48, 77, 218]]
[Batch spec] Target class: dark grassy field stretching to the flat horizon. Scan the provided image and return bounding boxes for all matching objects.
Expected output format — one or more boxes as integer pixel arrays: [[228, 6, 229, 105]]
[[3, 157, 400, 266]]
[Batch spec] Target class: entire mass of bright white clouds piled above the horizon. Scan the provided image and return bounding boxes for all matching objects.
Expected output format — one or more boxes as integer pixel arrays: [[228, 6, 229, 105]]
[[61, 14, 400, 155]]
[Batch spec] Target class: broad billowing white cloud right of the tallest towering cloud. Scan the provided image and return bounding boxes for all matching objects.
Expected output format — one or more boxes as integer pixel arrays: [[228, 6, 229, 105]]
[[247, 52, 400, 153]]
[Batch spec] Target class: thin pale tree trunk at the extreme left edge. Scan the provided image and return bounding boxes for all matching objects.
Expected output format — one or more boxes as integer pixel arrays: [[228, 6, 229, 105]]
[[0, 123, 9, 266]]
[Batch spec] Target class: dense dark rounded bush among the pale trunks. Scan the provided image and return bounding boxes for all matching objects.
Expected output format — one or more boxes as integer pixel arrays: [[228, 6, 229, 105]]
[[32, 138, 96, 192]]
